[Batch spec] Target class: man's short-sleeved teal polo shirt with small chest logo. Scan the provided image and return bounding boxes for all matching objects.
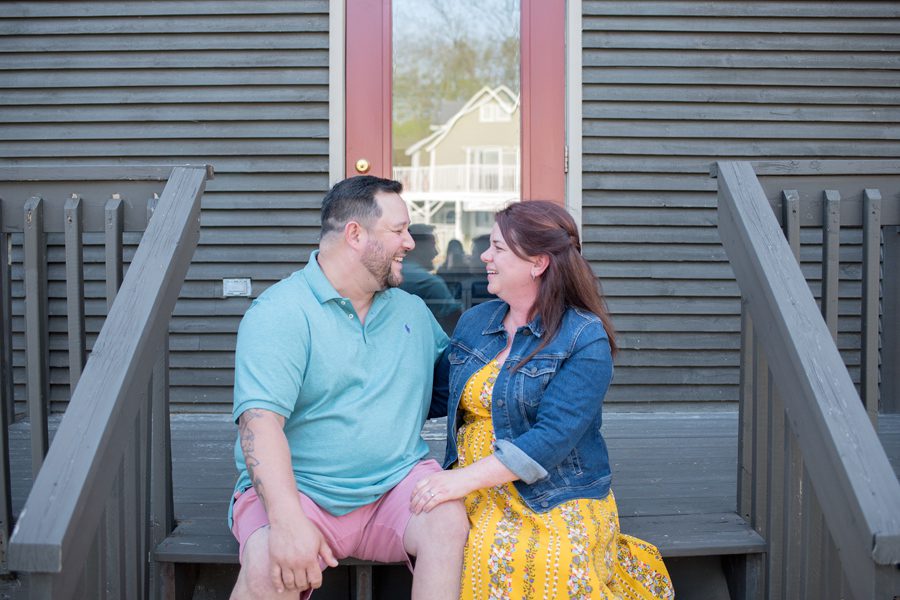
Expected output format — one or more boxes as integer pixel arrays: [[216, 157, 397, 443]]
[[232, 252, 448, 515]]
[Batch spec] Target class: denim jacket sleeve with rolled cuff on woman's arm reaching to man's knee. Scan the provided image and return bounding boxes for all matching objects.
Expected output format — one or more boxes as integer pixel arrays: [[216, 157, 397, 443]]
[[497, 323, 613, 483]]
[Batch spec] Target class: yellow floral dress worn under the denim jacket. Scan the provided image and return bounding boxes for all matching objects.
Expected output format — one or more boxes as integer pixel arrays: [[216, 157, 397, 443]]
[[456, 361, 675, 600]]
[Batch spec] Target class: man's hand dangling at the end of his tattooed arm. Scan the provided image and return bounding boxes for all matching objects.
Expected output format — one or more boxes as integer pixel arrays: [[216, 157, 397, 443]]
[[269, 515, 338, 594]]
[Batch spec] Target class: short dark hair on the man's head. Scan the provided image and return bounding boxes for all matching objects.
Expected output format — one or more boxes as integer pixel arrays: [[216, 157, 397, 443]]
[[321, 175, 403, 237]]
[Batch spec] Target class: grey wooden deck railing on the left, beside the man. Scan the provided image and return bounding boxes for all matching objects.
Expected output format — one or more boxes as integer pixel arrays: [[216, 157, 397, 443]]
[[0, 166, 212, 599]]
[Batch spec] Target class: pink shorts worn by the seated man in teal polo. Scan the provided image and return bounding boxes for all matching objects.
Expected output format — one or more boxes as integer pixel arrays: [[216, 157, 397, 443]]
[[231, 459, 441, 570]]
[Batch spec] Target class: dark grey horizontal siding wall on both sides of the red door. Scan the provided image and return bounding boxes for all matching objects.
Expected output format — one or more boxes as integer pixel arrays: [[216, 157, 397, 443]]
[[0, 0, 900, 411]]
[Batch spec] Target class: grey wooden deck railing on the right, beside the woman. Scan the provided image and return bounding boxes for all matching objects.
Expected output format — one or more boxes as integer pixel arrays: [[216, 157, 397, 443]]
[[713, 161, 900, 599]]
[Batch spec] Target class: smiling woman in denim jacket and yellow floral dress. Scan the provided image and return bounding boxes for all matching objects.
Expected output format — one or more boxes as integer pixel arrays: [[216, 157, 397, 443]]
[[411, 201, 674, 600]]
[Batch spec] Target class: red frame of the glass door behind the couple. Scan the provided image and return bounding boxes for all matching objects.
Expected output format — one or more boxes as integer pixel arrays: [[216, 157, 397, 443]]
[[344, 0, 566, 205]]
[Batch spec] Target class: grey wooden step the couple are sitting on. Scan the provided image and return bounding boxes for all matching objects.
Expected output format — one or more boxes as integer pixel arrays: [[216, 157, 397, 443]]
[[155, 513, 766, 565]]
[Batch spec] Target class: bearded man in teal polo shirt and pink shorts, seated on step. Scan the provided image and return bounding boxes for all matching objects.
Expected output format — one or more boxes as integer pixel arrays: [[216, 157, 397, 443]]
[[232, 176, 468, 599]]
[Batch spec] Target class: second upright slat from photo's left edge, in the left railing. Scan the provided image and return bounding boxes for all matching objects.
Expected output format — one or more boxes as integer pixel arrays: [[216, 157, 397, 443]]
[[23, 197, 50, 476]]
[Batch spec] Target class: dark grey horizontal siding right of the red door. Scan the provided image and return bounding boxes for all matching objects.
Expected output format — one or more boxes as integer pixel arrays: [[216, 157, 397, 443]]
[[582, 0, 900, 405]]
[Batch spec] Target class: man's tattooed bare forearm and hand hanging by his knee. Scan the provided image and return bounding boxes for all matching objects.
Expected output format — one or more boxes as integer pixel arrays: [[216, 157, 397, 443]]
[[238, 408, 337, 593]]
